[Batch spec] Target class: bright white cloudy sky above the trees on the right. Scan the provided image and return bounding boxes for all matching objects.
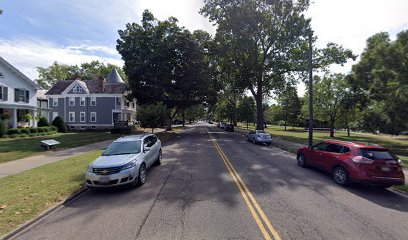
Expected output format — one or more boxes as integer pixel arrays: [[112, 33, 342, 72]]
[[307, 0, 408, 72]]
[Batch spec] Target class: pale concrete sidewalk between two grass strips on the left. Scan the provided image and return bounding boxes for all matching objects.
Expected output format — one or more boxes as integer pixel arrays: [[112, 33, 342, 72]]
[[0, 140, 113, 178]]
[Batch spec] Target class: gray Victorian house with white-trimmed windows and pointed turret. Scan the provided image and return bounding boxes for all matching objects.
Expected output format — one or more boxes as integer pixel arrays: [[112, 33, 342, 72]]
[[45, 69, 136, 130]]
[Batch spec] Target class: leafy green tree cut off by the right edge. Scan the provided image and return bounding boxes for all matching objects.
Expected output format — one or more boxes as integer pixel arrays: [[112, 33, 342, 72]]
[[349, 30, 408, 134]]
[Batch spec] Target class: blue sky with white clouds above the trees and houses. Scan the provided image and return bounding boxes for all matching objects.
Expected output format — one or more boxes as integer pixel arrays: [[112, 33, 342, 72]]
[[0, 0, 408, 94]]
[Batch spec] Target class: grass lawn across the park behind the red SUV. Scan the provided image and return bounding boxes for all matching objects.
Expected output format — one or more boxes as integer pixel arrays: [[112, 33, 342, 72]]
[[239, 124, 408, 167]]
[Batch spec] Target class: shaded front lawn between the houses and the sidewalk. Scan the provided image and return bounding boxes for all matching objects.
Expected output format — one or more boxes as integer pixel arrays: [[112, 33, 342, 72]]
[[0, 132, 120, 163]]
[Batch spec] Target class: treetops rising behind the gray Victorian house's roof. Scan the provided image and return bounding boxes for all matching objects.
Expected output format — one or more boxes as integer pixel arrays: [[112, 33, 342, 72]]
[[36, 61, 127, 89]]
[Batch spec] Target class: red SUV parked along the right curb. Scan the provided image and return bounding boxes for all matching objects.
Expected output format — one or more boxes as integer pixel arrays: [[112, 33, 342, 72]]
[[297, 140, 405, 187]]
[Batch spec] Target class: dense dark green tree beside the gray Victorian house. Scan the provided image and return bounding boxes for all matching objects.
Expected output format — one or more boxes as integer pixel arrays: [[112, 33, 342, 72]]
[[116, 10, 210, 130]]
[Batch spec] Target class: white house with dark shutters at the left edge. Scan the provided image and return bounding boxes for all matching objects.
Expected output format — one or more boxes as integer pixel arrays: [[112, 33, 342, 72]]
[[0, 57, 40, 128]]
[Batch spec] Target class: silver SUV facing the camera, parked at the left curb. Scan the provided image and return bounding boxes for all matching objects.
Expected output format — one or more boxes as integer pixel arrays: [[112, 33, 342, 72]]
[[85, 134, 162, 189]]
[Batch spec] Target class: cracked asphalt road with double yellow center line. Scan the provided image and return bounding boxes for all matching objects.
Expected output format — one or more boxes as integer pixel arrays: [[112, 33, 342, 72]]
[[9, 124, 408, 240]]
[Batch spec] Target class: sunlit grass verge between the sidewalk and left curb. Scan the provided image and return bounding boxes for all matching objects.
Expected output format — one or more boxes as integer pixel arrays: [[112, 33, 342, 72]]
[[0, 132, 178, 236]]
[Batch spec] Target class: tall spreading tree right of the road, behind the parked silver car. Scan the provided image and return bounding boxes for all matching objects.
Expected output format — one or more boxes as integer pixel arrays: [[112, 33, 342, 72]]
[[201, 0, 352, 129]]
